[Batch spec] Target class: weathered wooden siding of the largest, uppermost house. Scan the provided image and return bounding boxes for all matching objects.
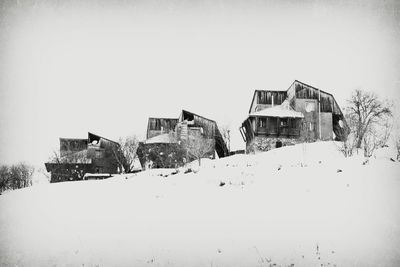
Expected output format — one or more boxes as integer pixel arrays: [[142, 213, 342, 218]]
[[240, 80, 349, 148]]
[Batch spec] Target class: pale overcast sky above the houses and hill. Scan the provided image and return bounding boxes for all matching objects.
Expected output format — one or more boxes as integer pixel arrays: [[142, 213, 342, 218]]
[[0, 0, 400, 168]]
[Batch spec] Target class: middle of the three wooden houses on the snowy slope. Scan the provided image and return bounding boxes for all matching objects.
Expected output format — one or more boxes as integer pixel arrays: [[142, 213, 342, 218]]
[[137, 110, 229, 168]]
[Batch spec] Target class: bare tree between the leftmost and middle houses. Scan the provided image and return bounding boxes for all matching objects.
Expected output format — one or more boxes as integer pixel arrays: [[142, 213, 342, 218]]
[[113, 135, 139, 173]]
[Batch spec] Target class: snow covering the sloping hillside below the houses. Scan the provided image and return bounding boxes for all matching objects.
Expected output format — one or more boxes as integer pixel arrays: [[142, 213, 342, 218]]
[[0, 142, 400, 266]]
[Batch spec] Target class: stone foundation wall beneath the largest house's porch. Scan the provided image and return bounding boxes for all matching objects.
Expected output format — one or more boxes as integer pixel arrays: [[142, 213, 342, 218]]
[[246, 136, 302, 154]]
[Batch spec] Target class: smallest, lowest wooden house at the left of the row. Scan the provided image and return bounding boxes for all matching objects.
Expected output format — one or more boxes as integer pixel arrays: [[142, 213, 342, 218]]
[[45, 133, 119, 183]]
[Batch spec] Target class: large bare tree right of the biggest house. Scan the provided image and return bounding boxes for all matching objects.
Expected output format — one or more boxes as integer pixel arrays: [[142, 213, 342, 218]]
[[347, 90, 392, 151]]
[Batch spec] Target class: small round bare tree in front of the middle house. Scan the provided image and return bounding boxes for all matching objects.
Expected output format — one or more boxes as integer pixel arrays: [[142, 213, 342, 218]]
[[186, 134, 215, 166]]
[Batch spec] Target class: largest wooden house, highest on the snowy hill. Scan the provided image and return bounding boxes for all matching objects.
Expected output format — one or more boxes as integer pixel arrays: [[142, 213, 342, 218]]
[[240, 80, 349, 153]]
